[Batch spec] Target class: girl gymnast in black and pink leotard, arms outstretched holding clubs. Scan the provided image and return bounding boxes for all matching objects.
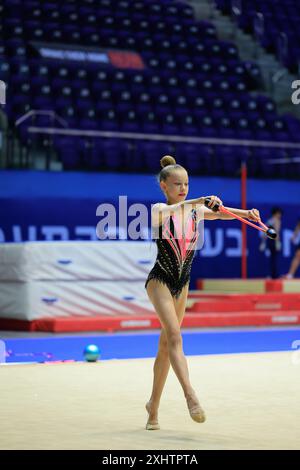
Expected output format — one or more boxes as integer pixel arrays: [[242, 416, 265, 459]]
[[145, 156, 260, 430]]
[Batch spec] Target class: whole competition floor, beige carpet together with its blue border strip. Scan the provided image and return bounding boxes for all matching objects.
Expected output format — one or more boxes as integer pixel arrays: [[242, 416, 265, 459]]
[[0, 328, 300, 451]]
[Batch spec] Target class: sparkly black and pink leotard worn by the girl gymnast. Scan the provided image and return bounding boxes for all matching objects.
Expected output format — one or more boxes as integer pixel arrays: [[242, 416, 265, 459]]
[[145, 209, 198, 298]]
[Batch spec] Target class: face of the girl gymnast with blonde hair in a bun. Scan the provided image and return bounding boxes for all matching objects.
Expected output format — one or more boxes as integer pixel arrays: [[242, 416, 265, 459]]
[[160, 170, 189, 204]]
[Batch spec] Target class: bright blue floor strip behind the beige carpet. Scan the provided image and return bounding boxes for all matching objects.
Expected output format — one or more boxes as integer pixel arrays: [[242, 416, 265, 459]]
[[0, 328, 300, 363]]
